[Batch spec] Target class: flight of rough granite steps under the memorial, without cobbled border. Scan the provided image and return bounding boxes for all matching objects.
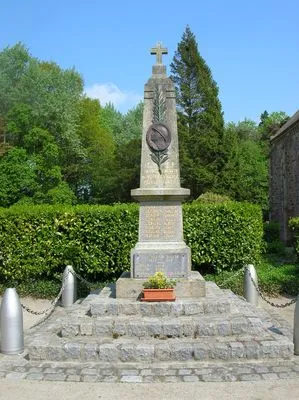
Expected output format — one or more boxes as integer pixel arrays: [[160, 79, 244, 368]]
[[25, 283, 294, 379]]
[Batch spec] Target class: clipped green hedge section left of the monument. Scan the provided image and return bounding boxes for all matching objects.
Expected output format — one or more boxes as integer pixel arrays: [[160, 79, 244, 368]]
[[0, 205, 138, 281]]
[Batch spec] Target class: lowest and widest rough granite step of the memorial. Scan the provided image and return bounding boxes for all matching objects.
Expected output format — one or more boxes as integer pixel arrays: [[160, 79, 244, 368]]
[[27, 335, 294, 363]]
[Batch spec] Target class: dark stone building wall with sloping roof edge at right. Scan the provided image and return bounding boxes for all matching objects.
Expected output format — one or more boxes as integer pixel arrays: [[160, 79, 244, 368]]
[[270, 111, 299, 242]]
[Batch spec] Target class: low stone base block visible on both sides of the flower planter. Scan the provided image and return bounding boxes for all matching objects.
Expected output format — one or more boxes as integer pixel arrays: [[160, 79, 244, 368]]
[[116, 271, 206, 300]]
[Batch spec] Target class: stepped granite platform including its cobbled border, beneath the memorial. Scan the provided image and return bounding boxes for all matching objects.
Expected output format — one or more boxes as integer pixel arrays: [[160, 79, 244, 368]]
[[0, 282, 299, 382]]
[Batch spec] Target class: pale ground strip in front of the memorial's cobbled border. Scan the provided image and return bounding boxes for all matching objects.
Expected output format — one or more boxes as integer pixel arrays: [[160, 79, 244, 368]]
[[0, 379, 299, 400]]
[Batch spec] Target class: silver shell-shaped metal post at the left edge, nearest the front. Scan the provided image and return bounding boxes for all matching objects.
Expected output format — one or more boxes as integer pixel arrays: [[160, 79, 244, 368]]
[[0, 288, 24, 354]]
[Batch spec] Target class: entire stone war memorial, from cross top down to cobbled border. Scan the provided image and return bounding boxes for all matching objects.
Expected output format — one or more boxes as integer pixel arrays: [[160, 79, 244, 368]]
[[0, 43, 299, 383]]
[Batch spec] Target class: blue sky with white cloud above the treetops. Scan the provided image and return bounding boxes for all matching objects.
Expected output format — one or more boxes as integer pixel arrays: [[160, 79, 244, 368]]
[[0, 0, 299, 122]]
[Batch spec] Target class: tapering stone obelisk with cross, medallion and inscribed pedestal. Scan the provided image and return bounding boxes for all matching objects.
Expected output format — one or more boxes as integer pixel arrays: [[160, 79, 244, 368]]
[[131, 43, 191, 278]]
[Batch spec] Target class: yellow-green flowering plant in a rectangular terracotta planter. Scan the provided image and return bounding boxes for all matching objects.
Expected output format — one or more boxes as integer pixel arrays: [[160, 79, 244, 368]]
[[141, 271, 176, 301]]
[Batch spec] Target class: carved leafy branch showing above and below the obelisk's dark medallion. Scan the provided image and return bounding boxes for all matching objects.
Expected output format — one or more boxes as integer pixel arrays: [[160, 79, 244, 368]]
[[151, 85, 169, 174]]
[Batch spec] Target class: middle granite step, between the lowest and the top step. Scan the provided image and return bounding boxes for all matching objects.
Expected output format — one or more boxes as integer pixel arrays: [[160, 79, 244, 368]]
[[57, 314, 265, 339]]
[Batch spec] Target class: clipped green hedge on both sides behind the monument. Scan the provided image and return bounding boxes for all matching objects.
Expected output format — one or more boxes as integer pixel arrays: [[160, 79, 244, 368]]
[[0, 202, 262, 283]]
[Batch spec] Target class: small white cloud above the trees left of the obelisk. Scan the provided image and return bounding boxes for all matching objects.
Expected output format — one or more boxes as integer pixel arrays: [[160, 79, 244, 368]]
[[85, 83, 142, 112]]
